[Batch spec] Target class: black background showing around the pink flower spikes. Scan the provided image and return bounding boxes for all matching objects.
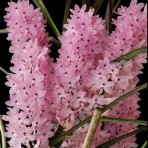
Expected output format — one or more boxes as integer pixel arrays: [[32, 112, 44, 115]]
[[0, 0, 148, 145]]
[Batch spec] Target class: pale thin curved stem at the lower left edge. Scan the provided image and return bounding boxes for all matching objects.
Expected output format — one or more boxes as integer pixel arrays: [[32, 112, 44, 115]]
[[0, 115, 6, 148]]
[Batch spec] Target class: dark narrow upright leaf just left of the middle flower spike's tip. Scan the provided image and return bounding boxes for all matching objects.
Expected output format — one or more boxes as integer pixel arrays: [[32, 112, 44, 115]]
[[63, 0, 72, 31]]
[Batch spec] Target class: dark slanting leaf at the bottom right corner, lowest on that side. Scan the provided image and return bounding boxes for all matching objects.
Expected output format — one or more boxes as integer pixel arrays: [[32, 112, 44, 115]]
[[97, 126, 147, 148]]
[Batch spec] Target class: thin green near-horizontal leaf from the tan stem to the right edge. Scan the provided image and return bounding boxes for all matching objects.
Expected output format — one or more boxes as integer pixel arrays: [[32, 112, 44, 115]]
[[100, 117, 147, 126]]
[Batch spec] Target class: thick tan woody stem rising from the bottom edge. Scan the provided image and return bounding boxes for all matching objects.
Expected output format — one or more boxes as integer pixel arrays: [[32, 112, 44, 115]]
[[82, 108, 102, 148]]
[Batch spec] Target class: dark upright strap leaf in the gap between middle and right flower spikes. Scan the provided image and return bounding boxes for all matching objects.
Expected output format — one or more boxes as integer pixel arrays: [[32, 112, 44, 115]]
[[105, 0, 112, 33]]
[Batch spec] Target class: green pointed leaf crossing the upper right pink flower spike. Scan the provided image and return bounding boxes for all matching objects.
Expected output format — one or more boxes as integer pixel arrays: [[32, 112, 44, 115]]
[[112, 47, 147, 62]]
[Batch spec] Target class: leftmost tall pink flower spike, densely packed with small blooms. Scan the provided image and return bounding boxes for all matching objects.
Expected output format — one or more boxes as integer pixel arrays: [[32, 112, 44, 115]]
[[3, 0, 55, 148]]
